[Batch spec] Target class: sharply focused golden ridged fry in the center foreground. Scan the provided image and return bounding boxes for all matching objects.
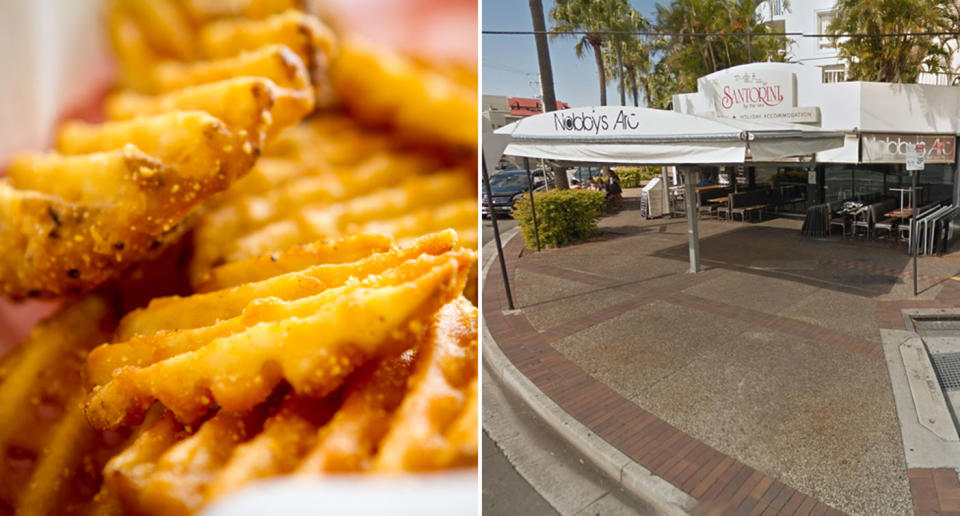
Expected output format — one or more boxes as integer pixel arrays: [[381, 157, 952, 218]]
[[87, 246, 475, 428]]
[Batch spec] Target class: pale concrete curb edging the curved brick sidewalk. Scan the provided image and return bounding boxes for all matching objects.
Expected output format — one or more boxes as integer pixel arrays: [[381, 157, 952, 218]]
[[480, 228, 696, 515]]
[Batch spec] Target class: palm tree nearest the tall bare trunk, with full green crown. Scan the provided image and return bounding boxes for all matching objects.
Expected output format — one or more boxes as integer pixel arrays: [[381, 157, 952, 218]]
[[550, 0, 630, 106]]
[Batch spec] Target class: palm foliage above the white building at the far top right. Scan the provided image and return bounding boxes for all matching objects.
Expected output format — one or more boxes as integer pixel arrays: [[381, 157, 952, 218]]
[[827, 0, 949, 82]]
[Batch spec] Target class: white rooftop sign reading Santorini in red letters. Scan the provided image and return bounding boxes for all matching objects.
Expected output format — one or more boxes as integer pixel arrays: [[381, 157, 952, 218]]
[[697, 67, 820, 123]]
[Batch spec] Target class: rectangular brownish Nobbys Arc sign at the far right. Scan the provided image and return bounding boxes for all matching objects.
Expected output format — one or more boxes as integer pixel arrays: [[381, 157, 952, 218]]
[[860, 133, 957, 165]]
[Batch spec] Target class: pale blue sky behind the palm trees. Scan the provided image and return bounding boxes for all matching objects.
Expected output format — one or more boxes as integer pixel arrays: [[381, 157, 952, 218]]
[[481, 0, 657, 107]]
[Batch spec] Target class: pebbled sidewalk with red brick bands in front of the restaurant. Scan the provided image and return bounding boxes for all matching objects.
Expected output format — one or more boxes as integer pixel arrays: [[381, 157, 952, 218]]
[[483, 199, 960, 514]]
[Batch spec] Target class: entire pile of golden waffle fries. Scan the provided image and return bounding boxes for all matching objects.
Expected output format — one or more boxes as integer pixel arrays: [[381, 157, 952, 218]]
[[0, 0, 478, 514]]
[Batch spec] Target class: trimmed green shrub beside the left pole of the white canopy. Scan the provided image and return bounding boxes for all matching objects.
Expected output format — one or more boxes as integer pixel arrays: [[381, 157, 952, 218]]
[[513, 190, 606, 249]]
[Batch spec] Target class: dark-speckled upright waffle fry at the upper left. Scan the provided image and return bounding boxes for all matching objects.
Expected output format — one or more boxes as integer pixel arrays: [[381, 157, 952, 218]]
[[0, 12, 326, 298]]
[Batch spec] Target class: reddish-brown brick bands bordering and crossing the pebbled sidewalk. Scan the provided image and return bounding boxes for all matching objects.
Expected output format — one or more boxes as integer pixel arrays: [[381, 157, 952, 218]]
[[484, 216, 960, 514]]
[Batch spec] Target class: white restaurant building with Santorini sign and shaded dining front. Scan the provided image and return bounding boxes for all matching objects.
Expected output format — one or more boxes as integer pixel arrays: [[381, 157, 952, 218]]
[[673, 63, 960, 214]]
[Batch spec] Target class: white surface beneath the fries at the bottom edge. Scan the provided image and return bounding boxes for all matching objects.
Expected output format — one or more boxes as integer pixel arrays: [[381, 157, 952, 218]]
[[202, 472, 479, 516]]
